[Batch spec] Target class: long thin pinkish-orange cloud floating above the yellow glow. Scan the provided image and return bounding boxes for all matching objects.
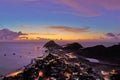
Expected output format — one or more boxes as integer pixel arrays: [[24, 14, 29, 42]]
[[47, 26, 89, 33]]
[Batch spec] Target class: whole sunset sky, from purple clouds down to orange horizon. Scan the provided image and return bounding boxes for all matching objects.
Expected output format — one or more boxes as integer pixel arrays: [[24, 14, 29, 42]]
[[0, 0, 120, 41]]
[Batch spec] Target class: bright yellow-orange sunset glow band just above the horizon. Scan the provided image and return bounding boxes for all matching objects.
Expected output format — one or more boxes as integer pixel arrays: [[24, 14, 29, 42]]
[[16, 31, 106, 41]]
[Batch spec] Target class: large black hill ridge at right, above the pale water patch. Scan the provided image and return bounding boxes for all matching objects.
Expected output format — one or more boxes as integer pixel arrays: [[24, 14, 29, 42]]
[[77, 45, 120, 64]]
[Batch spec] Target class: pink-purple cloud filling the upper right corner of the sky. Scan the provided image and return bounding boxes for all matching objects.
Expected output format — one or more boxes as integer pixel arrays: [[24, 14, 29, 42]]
[[58, 0, 120, 17]]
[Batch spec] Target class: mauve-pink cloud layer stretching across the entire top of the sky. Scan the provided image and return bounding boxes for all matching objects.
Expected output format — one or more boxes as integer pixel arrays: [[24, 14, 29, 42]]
[[0, 0, 120, 17]]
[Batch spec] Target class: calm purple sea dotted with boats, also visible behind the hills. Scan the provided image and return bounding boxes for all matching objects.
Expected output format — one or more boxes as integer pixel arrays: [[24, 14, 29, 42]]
[[0, 41, 116, 75]]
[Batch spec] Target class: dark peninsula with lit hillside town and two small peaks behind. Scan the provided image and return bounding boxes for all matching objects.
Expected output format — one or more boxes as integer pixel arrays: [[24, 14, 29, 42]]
[[2, 41, 120, 80]]
